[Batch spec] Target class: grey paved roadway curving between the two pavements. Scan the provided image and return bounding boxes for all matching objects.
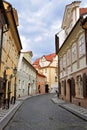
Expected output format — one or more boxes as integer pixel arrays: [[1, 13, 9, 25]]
[[4, 94, 87, 130]]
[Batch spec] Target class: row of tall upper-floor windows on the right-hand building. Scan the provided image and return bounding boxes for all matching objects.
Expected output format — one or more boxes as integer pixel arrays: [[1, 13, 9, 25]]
[[60, 34, 85, 70]]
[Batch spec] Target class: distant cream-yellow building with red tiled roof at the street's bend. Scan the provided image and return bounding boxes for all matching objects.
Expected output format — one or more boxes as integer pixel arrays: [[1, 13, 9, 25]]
[[33, 53, 58, 91]]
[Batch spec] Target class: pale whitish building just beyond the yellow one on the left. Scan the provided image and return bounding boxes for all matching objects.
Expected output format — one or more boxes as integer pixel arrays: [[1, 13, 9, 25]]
[[17, 51, 37, 97]]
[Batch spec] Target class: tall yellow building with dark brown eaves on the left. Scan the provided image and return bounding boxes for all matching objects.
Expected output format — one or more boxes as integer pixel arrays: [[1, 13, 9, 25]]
[[0, 1, 22, 108]]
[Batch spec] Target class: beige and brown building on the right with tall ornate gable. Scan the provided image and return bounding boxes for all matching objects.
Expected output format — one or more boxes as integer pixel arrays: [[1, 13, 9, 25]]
[[56, 1, 87, 108]]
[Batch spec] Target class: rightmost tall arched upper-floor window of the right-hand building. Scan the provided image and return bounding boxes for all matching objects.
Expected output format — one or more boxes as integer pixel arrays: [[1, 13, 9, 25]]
[[79, 36, 85, 57]]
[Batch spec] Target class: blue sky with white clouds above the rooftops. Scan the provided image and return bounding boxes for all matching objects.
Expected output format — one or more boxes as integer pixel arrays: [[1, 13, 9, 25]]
[[6, 0, 87, 61]]
